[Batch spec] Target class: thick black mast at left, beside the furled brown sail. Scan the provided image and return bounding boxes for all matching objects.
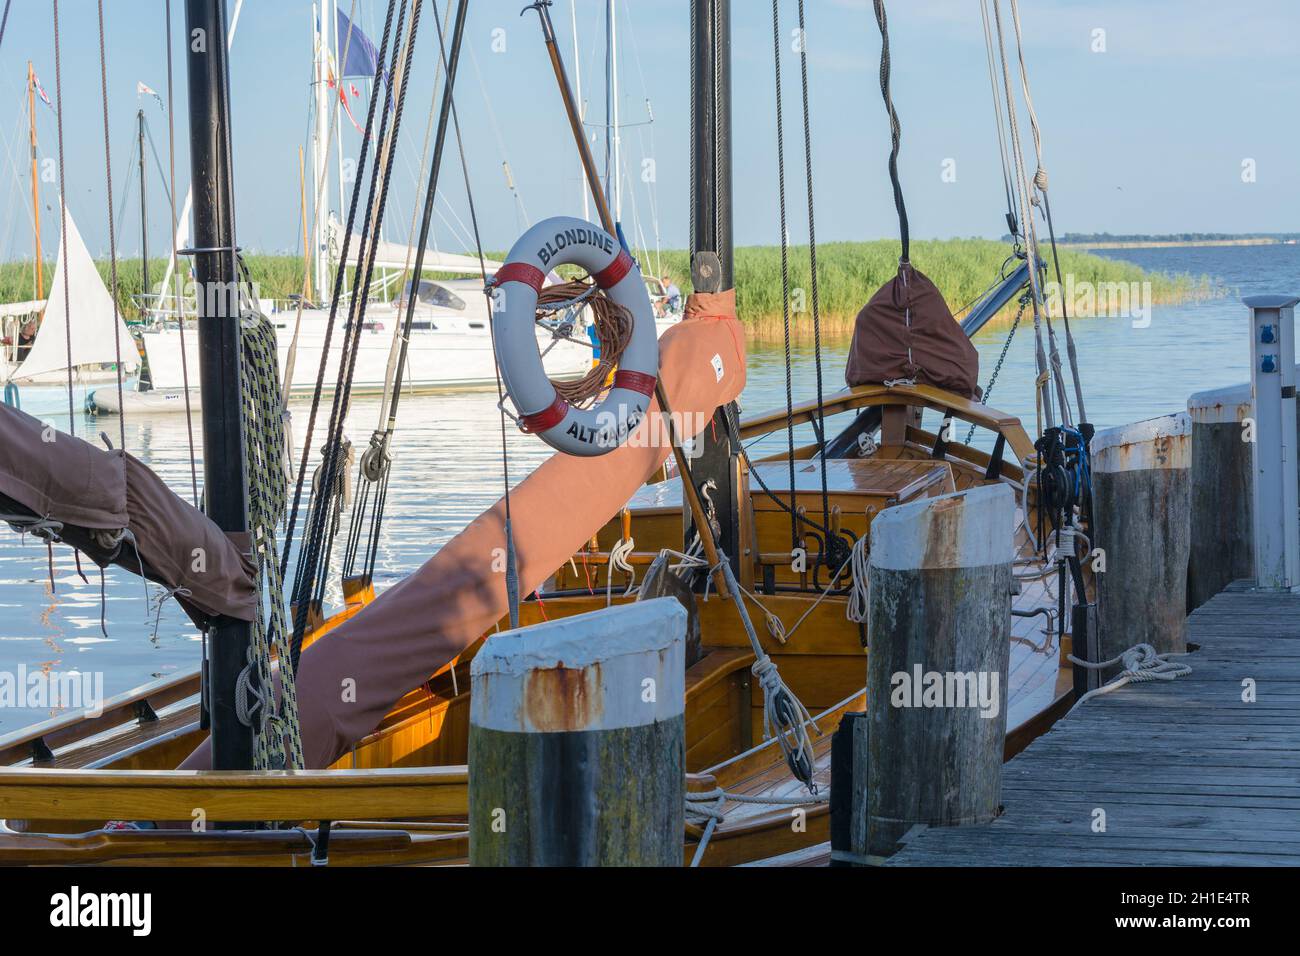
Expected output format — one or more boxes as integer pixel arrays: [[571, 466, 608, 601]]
[[185, 0, 254, 770]]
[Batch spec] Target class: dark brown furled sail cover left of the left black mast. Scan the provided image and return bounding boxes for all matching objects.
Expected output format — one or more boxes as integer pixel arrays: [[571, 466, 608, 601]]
[[0, 405, 257, 626]]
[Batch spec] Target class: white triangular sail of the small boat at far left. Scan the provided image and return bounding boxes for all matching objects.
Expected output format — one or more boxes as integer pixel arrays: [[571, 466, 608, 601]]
[[13, 204, 140, 378]]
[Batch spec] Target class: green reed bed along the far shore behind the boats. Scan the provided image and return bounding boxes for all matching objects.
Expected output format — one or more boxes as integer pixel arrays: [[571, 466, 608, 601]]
[[0, 239, 1225, 338]]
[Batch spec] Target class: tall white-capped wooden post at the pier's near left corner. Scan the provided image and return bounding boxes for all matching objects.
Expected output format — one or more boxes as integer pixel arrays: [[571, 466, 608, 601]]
[[854, 485, 1015, 858]]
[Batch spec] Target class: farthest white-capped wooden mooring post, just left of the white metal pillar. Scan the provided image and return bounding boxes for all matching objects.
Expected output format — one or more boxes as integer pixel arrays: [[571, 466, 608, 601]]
[[1187, 382, 1255, 614]]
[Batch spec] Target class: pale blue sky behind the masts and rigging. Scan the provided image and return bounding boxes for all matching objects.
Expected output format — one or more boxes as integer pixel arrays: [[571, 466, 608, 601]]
[[0, 0, 1300, 259]]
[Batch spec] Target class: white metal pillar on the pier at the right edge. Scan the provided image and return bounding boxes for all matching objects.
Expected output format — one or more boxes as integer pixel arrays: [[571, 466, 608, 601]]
[[1243, 295, 1300, 591]]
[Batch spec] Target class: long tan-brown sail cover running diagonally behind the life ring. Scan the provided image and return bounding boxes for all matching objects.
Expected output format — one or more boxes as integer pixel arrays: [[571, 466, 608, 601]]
[[182, 291, 745, 769]]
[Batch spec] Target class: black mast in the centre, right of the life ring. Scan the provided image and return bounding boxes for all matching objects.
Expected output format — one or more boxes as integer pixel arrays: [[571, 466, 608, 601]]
[[683, 0, 741, 588]]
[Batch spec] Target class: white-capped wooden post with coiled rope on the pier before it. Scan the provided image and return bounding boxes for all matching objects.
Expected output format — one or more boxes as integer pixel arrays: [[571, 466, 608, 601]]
[[1092, 412, 1192, 676]]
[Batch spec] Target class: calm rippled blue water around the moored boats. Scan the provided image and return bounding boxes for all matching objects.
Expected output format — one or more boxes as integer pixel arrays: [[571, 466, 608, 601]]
[[0, 246, 1300, 735]]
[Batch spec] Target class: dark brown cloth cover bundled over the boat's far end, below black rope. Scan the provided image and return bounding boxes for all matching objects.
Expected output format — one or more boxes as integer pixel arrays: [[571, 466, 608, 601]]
[[844, 264, 979, 398]]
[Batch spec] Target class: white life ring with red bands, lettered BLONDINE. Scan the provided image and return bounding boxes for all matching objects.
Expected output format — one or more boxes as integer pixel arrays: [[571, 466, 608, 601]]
[[491, 216, 659, 458]]
